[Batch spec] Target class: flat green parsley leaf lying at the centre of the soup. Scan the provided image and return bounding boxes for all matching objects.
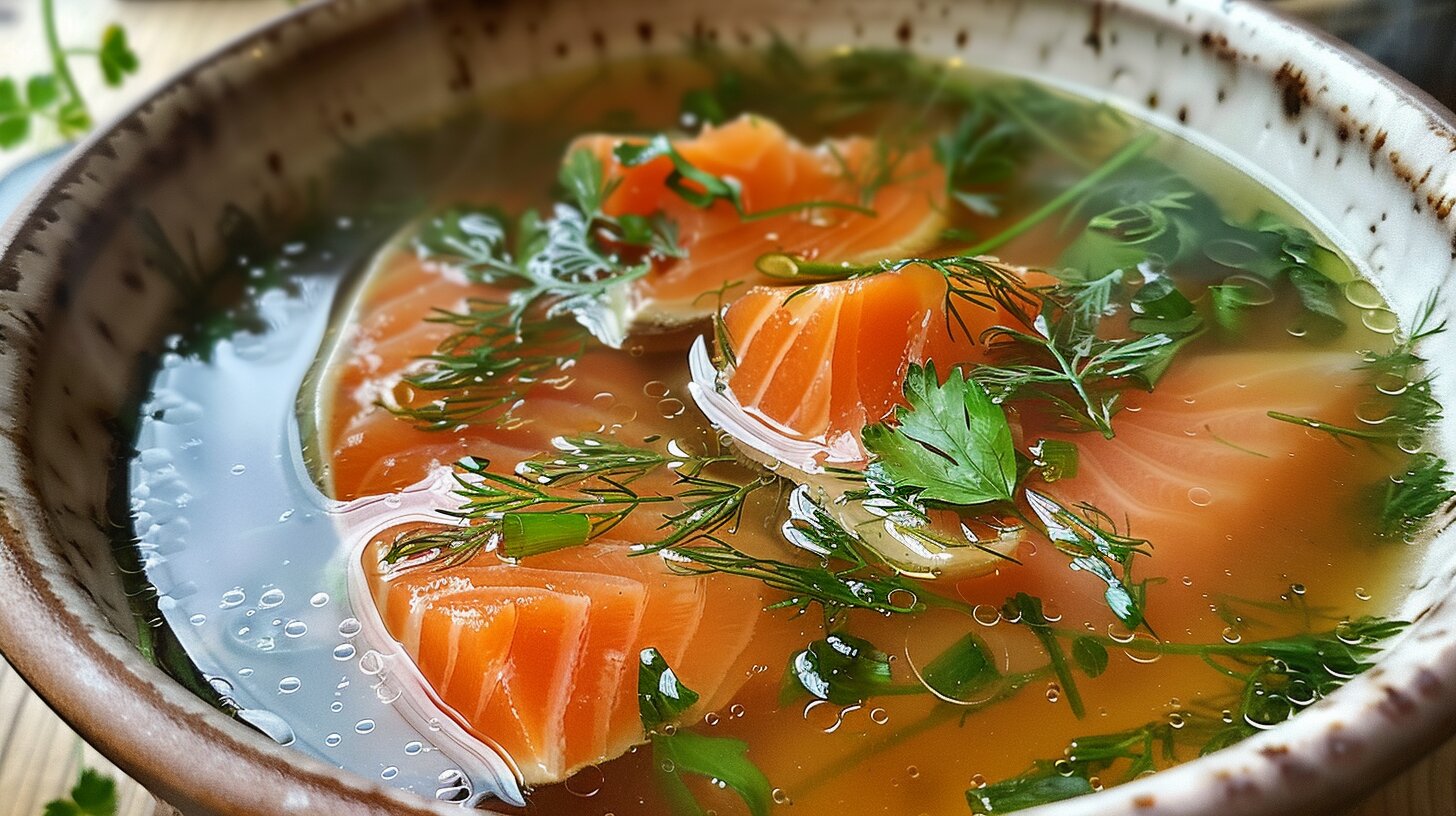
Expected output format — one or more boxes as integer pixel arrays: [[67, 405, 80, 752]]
[[863, 363, 1016, 506]]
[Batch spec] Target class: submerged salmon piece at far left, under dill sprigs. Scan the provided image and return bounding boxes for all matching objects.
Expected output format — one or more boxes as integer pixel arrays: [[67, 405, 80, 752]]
[[321, 251, 711, 541]]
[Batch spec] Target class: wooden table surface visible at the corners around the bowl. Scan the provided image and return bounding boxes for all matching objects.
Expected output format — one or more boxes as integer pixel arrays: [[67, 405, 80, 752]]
[[0, 0, 1456, 816]]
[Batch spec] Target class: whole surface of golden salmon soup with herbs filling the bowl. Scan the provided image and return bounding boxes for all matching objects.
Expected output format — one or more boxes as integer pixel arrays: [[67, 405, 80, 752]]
[[130, 47, 1450, 816]]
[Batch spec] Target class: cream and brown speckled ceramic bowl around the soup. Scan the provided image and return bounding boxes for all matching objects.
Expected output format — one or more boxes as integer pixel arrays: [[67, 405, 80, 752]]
[[0, 0, 1456, 816]]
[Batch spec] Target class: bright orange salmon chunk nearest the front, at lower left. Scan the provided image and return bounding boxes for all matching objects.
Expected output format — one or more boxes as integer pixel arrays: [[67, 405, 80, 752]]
[[360, 539, 763, 785]]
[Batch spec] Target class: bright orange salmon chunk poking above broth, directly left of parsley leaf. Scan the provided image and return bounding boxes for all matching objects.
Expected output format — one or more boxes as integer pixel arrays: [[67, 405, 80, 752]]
[[697, 265, 1044, 469]]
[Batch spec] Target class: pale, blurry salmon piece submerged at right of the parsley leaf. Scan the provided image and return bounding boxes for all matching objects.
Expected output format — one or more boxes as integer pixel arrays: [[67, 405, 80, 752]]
[[958, 351, 1377, 632]]
